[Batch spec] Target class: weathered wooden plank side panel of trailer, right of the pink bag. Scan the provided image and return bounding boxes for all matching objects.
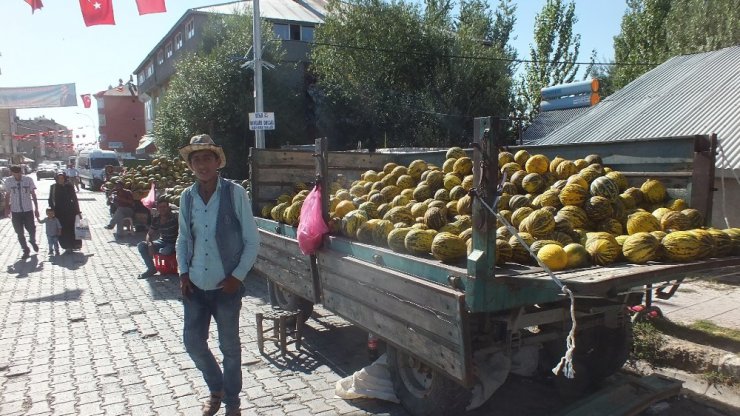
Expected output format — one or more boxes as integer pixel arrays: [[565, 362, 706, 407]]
[[316, 249, 472, 385]]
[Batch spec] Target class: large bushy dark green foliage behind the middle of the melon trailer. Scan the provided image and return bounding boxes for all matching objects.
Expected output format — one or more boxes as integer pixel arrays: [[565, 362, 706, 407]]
[[312, 0, 515, 148]]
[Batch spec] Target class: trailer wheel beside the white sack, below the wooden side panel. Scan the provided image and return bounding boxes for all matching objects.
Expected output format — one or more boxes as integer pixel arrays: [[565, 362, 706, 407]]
[[386, 345, 472, 416]]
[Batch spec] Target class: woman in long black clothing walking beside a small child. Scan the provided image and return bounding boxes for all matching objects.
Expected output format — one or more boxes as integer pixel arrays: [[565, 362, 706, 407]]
[[49, 172, 82, 254]]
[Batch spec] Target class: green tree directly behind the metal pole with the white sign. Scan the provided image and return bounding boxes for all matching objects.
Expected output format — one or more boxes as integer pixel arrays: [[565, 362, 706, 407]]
[[154, 13, 305, 178]]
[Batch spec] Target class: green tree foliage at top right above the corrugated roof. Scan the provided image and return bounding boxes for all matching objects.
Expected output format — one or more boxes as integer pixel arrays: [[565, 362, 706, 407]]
[[608, 0, 740, 89]]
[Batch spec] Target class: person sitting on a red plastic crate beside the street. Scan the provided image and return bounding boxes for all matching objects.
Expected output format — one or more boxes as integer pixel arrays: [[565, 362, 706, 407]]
[[137, 196, 178, 279]]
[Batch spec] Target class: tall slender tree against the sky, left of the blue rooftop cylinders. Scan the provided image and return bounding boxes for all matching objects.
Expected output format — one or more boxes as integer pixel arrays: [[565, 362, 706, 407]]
[[515, 0, 581, 120]]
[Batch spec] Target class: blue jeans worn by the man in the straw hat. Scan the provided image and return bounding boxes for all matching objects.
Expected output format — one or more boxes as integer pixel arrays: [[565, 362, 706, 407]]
[[182, 285, 246, 407]]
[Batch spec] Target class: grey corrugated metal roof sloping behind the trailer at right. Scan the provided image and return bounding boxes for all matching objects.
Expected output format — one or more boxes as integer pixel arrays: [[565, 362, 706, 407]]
[[536, 46, 740, 169]]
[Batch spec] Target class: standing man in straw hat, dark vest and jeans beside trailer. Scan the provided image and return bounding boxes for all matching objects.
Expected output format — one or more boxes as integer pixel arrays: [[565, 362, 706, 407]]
[[176, 134, 260, 416]]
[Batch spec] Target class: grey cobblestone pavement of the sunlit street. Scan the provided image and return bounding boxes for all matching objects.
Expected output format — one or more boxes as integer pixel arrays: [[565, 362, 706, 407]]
[[0, 180, 406, 416]]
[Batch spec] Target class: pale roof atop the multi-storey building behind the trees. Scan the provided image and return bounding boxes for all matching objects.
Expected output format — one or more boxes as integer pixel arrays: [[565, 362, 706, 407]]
[[195, 0, 327, 24]]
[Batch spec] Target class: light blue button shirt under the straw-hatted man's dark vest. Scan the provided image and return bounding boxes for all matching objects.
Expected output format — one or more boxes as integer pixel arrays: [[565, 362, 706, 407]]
[[178, 182, 260, 290]]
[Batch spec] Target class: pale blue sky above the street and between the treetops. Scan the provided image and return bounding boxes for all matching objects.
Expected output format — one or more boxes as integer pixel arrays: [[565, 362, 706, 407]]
[[0, 0, 626, 142]]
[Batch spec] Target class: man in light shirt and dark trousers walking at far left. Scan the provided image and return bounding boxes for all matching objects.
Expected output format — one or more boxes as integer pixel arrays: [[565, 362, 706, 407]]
[[4, 165, 39, 259]]
